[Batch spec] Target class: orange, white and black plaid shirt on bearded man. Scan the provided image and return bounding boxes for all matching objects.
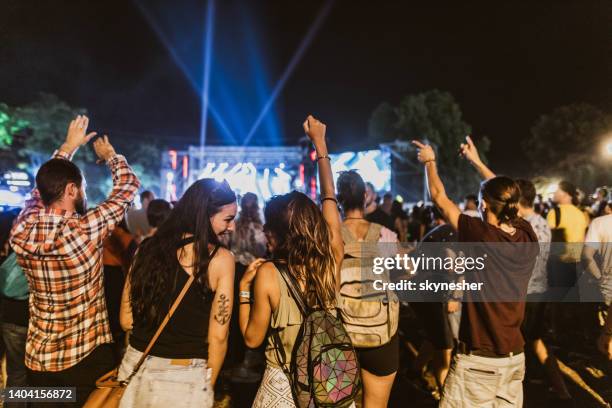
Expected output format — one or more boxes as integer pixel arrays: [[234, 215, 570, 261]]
[[10, 151, 140, 371]]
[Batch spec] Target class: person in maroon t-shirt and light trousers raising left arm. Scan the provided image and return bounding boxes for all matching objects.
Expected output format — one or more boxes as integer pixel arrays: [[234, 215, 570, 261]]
[[412, 141, 538, 408]]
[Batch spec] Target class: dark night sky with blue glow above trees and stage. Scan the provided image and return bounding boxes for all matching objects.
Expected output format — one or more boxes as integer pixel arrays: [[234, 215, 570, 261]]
[[0, 0, 612, 174]]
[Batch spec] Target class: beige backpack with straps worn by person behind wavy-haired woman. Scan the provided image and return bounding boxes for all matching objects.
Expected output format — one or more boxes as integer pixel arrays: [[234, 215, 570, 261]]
[[340, 223, 399, 348]]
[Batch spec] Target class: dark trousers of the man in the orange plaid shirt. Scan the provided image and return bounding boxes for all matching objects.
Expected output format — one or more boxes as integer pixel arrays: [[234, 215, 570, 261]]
[[28, 344, 116, 408]]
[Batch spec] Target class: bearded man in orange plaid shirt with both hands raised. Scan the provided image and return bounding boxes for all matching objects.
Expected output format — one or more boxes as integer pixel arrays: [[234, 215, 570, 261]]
[[10, 116, 140, 407]]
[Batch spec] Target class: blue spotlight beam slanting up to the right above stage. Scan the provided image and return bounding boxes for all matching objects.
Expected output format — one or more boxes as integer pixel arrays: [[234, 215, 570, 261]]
[[242, 0, 334, 146]]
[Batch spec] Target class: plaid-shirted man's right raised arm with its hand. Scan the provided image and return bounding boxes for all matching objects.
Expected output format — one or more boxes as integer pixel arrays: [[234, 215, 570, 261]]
[[81, 136, 140, 245]]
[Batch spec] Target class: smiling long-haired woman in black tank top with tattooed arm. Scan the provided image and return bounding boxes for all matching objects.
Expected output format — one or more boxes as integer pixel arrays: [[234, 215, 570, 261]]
[[119, 179, 237, 408]]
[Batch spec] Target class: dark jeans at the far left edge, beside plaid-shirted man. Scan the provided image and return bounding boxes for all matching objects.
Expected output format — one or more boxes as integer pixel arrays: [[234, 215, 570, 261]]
[[2, 323, 28, 408]]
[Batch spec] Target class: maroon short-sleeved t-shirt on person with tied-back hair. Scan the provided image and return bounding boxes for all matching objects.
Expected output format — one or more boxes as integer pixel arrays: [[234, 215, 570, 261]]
[[458, 214, 538, 354]]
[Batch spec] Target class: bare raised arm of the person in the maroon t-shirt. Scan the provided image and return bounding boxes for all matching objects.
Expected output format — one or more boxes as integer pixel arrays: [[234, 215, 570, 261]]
[[412, 140, 461, 230]]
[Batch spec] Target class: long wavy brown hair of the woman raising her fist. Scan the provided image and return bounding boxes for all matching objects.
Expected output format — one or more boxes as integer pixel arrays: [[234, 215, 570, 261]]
[[264, 191, 336, 308]]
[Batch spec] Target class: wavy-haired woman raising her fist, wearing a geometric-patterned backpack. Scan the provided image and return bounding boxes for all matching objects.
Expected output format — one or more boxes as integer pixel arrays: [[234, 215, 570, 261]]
[[240, 116, 343, 407]]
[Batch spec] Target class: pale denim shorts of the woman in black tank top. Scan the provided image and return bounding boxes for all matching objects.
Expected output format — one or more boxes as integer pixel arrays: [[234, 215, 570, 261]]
[[119, 346, 214, 408]]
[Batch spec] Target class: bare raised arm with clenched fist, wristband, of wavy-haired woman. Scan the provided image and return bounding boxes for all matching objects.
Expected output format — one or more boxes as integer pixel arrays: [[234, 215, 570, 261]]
[[304, 115, 344, 280]]
